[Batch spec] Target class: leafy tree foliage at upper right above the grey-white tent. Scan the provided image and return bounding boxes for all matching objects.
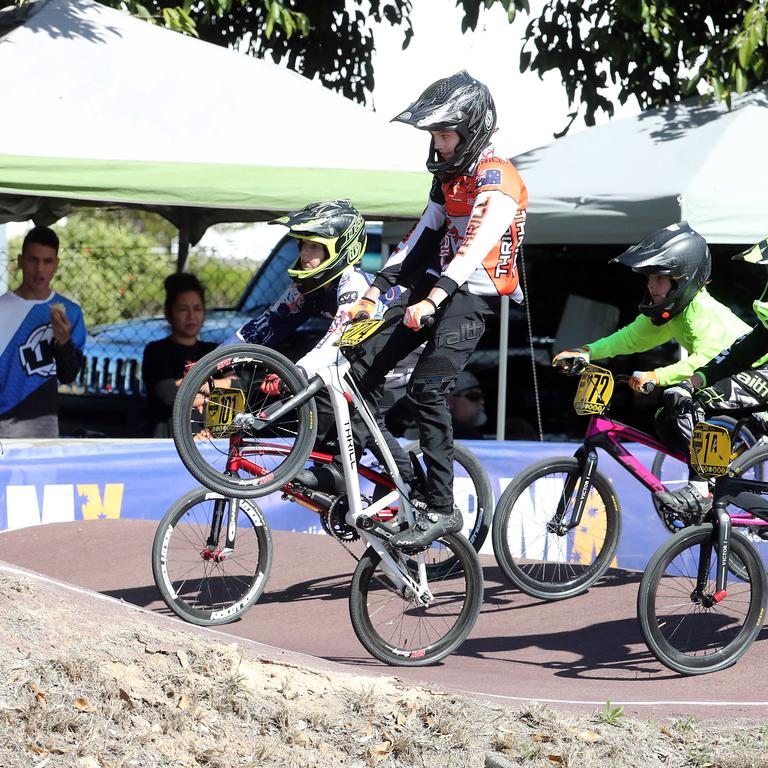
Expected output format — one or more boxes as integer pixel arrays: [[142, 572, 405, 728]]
[[520, 0, 768, 132]]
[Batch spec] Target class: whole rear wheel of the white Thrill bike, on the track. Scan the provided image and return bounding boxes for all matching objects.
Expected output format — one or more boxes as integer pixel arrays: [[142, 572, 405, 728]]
[[349, 534, 483, 667]]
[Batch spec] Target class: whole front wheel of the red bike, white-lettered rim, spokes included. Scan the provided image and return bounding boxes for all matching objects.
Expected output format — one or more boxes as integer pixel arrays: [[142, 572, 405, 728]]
[[152, 488, 272, 626]]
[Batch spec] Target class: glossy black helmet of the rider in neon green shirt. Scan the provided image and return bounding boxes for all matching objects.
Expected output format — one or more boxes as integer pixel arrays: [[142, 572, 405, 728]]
[[612, 221, 712, 325]]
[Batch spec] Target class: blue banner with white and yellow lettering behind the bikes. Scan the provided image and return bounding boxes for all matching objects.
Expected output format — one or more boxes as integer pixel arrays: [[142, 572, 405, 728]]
[[0, 440, 684, 568]]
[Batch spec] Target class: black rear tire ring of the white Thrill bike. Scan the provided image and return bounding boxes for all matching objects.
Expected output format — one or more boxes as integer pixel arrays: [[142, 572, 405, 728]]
[[349, 534, 483, 667]]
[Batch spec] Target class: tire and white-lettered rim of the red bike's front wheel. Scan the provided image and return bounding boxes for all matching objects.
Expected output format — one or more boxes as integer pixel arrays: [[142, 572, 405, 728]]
[[152, 488, 273, 627]]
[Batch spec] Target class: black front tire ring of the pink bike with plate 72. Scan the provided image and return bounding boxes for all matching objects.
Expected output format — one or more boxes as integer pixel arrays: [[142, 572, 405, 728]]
[[492, 456, 622, 600]]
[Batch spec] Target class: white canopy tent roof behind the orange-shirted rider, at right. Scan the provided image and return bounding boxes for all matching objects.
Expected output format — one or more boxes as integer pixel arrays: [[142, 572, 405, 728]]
[[514, 88, 768, 245]]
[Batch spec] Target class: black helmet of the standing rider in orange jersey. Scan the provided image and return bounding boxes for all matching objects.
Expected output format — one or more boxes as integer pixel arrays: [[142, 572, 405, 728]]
[[392, 69, 496, 181]]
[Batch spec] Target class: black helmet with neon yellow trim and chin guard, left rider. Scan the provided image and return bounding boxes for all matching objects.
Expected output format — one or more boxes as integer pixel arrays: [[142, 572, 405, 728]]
[[270, 200, 367, 294]]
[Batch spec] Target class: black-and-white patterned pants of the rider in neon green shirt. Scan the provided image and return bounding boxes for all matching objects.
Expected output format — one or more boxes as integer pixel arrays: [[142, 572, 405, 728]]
[[655, 366, 768, 480]]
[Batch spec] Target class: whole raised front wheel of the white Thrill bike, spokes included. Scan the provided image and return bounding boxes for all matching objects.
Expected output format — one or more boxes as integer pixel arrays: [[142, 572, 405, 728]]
[[173, 344, 317, 498]]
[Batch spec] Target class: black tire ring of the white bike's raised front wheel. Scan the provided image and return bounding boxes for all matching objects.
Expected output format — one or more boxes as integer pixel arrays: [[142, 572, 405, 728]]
[[173, 344, 317, 498]]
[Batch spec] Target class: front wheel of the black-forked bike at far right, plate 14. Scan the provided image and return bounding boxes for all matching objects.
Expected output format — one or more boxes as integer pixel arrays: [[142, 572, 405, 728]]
[[637, 523, 768, 675]]
